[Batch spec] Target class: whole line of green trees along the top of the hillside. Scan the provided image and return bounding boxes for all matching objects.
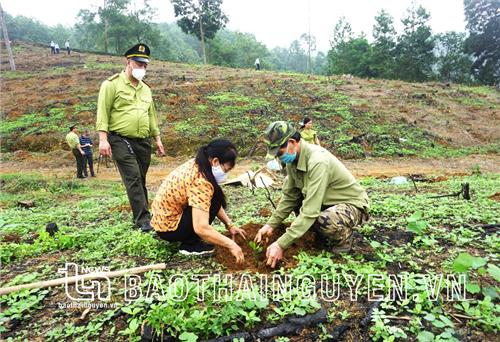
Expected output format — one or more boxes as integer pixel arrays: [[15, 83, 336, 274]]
[[1, 0, 500, 84]]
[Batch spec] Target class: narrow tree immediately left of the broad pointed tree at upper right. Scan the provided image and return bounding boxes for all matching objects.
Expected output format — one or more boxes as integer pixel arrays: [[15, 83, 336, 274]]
[[371, 10, 396, 78]]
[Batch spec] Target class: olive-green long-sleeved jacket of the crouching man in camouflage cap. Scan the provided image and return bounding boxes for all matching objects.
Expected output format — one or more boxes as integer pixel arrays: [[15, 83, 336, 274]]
[[267, 139, 369, 249]]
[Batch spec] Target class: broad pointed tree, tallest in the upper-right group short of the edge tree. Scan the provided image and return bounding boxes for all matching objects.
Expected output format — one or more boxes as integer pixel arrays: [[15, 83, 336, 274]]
[[396, 3, 434, 82]]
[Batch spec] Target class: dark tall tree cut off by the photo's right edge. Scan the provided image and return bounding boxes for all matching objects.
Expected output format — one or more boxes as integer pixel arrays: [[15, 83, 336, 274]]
[[464, 0, 500, 84]]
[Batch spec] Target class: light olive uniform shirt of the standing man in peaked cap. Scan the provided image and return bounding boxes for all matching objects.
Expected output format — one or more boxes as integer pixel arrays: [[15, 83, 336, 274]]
[[96, 71, 160, 138]]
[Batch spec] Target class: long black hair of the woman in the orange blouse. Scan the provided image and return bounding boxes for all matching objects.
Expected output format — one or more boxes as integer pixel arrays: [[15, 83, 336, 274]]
[[195, 139, 238, 208]]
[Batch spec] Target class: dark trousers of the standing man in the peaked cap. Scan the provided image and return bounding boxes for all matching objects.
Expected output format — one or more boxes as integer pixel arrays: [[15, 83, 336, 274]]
[[108, 133, 151, 226]]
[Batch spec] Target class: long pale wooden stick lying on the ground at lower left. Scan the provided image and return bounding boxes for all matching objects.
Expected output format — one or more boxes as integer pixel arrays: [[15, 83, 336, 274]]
[[0, 263, 166, 296]]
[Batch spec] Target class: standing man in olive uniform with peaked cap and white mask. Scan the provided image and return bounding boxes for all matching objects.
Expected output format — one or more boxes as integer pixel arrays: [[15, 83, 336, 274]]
[[96, 44, 165, 232]]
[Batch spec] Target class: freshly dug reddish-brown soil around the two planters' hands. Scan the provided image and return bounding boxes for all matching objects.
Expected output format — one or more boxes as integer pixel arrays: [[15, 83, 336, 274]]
[[215, 223, 316, 273]]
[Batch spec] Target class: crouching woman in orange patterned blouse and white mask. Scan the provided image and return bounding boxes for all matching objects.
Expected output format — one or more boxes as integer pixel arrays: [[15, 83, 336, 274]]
[[151, 139, 246, 263]]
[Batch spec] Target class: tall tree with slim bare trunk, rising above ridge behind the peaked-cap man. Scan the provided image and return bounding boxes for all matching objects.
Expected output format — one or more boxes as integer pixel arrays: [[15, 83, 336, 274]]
[[171, 0, 228, 64]]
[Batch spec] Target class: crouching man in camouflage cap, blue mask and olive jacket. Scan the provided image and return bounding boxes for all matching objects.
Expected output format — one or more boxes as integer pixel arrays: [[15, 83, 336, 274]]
[[255, 121, 369, 268]]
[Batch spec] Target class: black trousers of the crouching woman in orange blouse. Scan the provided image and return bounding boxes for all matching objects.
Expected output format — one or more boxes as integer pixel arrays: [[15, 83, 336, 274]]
[[156, 198, 222, 244]]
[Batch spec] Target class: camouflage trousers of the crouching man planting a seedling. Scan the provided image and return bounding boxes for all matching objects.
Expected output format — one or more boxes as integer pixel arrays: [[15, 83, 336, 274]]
[[312, 203, 368, 247]]
